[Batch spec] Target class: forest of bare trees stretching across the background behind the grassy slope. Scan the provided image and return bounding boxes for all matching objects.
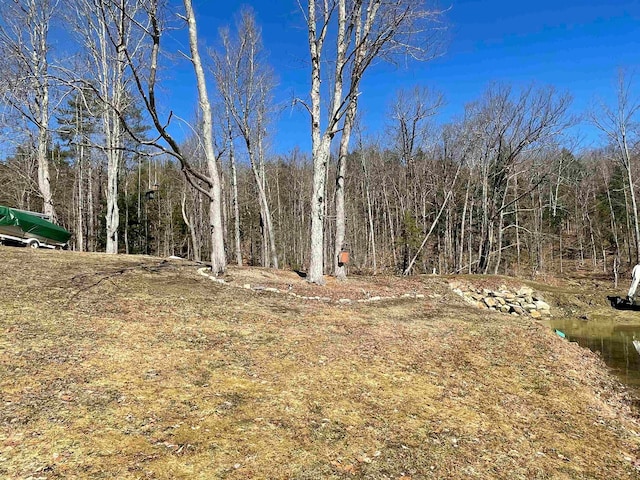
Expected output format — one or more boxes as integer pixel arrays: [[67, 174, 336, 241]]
[[0, 0, 640, 283]]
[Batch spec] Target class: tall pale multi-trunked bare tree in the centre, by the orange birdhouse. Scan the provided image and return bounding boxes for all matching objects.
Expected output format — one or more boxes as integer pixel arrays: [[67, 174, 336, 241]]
[[301, 0, 442, 284]]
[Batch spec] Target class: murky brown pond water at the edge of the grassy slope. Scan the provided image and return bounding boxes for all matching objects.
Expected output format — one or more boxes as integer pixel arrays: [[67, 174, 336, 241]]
[[548, 312, 640, 398]]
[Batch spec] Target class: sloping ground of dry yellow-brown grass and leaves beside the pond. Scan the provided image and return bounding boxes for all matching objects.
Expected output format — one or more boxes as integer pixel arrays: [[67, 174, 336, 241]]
[[0, 247, 640, 480]]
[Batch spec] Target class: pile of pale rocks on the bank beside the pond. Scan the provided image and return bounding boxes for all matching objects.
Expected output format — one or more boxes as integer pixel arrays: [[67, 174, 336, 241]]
[[449, 282, 551, 318]]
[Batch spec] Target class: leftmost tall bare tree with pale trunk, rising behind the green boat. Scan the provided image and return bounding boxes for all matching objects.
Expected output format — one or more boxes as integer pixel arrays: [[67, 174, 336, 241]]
[[0, 0, 58, 219]]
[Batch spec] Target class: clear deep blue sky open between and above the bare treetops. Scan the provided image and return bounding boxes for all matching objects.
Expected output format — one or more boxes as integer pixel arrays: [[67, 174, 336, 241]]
[[166, 0, 640, 152]]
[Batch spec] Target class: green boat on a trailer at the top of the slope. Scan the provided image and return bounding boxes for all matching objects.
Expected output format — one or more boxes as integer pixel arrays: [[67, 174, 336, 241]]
[[0, 205, 71, 248]]
